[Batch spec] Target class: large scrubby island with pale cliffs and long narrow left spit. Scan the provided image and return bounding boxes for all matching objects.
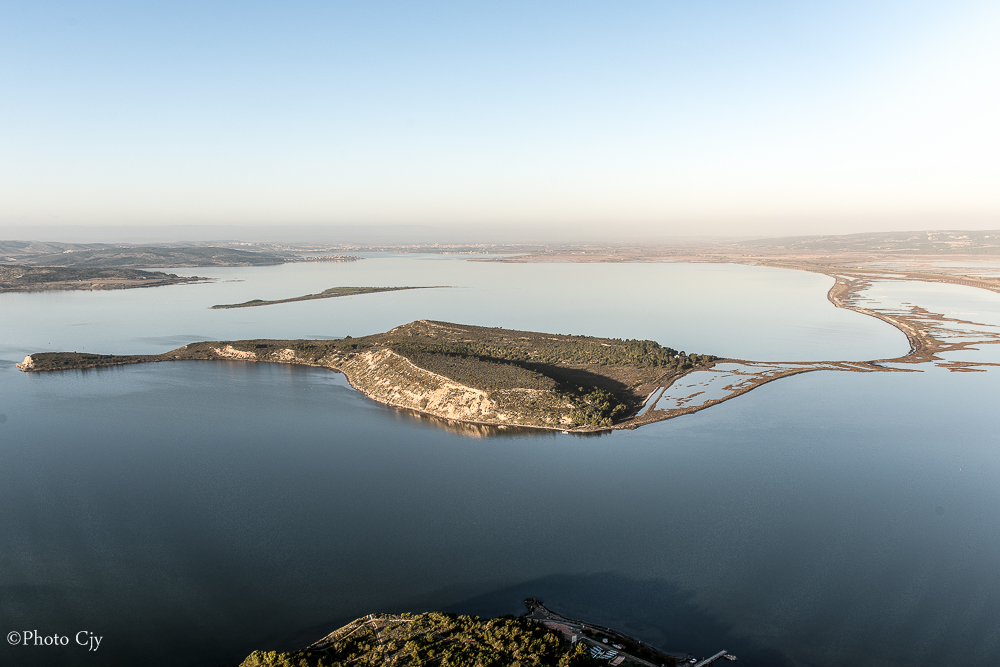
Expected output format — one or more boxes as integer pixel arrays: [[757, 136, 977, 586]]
[[19, 320, 715, 429]]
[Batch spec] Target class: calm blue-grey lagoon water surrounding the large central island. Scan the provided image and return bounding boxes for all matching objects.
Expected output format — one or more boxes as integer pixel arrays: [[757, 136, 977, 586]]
[[0, 256, 1000, 666]]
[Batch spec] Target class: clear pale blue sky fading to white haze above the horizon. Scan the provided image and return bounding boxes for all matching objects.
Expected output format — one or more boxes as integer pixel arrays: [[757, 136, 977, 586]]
[[0, 0, 1000, 234]]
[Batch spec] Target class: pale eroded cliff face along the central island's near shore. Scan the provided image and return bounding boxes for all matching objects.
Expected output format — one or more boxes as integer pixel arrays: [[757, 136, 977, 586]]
[[212, 345, 577, 428]]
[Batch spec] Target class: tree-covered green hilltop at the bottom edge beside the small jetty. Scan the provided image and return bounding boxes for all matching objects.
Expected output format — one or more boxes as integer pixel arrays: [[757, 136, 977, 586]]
[[241, 613, 607, 667]]
